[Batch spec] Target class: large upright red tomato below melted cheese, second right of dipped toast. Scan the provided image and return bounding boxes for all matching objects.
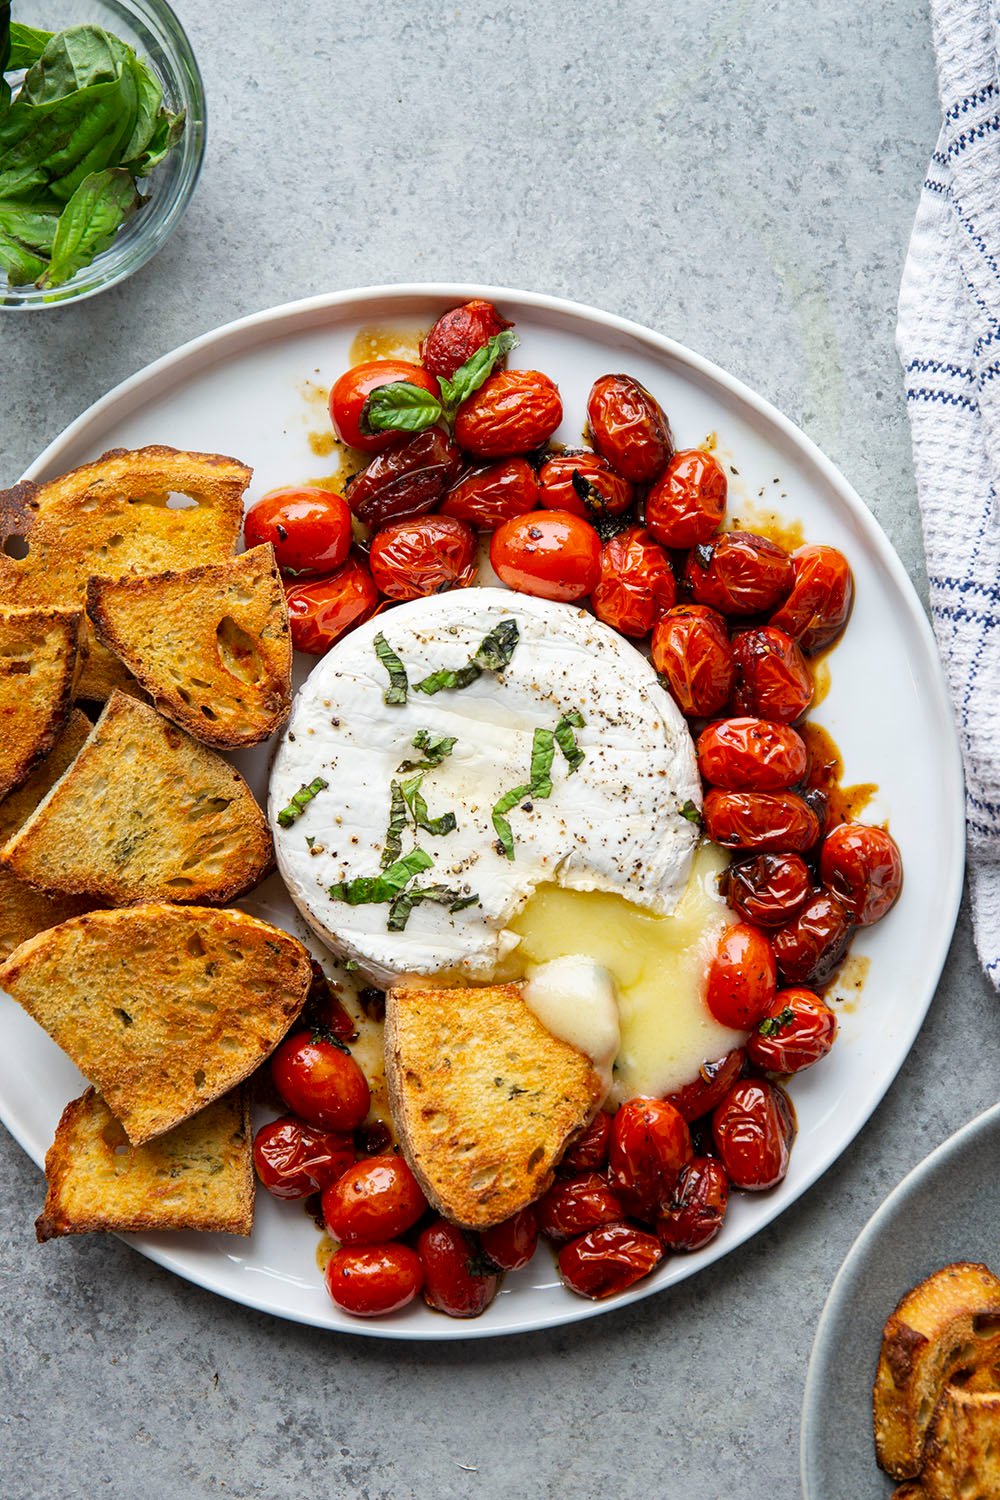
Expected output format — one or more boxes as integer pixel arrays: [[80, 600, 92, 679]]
[[609, 1098, 693, 1223]]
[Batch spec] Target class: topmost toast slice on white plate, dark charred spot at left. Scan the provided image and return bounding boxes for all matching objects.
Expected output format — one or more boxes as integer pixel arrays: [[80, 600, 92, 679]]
[[0, 446, 252, 699]]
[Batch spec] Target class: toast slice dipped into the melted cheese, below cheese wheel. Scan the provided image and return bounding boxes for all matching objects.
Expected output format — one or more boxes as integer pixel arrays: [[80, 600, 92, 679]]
[[385, 984, 604, 1229]]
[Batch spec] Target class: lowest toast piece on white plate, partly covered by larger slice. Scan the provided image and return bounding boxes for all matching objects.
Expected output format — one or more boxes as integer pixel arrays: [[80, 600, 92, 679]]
[[34, 1089, 253, 1241]]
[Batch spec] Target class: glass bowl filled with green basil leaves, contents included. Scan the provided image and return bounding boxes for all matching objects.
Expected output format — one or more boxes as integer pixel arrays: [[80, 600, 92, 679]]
[[0, 0, 205, 309]]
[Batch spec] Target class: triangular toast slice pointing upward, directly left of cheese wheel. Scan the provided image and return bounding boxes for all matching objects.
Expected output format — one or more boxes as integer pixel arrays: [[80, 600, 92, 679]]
[[0, 693, 273, 906]]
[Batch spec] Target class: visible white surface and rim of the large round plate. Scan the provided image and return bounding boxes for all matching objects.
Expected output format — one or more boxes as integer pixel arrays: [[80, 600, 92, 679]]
[[0, 285, 964, 1338]]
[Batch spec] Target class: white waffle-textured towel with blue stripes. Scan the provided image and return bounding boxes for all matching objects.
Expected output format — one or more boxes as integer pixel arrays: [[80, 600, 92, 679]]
[[897, 0, 1000, 987]]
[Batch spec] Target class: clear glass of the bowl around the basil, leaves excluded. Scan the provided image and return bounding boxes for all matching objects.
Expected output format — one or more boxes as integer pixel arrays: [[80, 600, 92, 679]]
[[0, 0, 205, 309]]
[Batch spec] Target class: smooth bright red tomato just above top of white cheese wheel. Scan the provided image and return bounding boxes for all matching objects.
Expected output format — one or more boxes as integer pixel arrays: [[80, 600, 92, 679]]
[[490, 510, 601, 603]]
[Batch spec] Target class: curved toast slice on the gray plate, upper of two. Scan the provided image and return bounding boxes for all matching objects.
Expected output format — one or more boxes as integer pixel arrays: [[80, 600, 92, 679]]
[[874, 1262, 1000, 1479]]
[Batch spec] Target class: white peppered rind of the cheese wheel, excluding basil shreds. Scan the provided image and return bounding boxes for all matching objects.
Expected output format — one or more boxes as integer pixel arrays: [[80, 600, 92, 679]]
[[268, 588, 702, 984]]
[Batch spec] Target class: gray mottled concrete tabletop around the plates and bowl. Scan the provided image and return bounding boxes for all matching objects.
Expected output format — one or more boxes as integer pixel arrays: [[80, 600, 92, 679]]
[[0, 0, 1000, 1500]]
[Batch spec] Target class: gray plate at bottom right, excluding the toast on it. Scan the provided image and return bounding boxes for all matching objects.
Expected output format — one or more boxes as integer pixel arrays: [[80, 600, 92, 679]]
[[802, 1104, 1000, 1500]]
